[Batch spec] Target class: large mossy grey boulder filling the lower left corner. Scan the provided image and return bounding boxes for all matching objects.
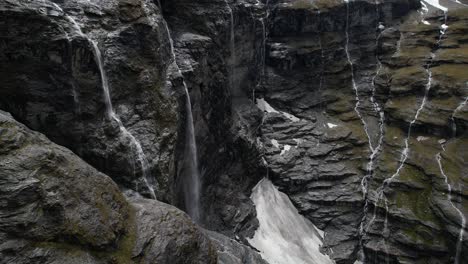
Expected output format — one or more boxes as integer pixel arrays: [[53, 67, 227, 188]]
[[0, 109, 130, 263]]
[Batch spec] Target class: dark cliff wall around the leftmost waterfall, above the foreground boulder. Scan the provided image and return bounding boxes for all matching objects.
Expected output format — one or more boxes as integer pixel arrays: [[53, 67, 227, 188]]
[[0, 1, 178, 200]]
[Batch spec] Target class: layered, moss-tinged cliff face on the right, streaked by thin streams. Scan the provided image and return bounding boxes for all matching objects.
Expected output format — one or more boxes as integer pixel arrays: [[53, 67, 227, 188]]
[[258, 1, 468, 263]]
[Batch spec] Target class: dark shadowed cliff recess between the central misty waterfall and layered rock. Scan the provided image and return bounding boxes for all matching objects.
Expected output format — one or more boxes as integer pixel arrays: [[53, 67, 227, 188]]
[[161, 1, 266, 237]]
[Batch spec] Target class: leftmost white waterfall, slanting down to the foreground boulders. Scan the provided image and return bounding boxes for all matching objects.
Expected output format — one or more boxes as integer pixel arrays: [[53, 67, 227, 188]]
[[53, 3, 156, 199]]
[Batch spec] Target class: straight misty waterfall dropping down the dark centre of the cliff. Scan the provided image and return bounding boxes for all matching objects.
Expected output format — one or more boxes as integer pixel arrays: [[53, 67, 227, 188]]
[[164, 23, 201, 222]]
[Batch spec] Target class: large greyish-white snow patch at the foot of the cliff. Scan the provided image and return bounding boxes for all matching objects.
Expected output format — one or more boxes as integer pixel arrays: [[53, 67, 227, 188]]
[[248, 178, 334, 264]]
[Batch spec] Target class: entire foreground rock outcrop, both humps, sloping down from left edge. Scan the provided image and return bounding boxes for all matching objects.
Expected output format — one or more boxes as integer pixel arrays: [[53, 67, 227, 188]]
[[0, 112, 264, 264]]
